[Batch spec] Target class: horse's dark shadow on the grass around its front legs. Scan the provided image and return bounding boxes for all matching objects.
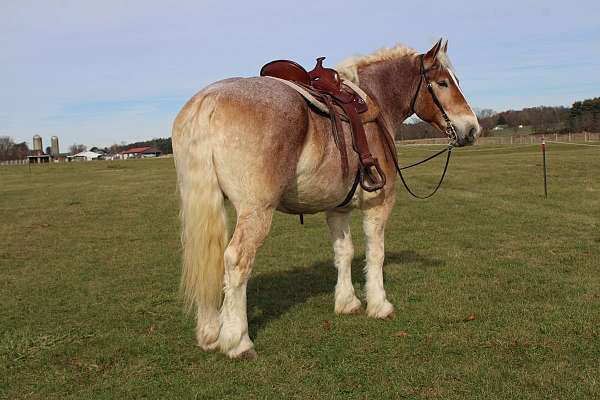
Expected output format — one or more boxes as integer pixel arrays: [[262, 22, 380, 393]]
[[248, 250, 444, 337]]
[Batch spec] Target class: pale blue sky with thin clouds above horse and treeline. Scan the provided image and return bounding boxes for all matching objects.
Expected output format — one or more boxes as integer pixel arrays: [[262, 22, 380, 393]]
[[0, 0, 600, 149]]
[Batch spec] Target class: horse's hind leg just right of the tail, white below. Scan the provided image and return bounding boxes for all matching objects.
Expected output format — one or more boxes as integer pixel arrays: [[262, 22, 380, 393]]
[[219, 207, 273, 358]]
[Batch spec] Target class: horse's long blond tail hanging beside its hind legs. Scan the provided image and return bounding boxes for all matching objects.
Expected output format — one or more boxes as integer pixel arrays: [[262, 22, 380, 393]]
[[173, 94, 228, 316]]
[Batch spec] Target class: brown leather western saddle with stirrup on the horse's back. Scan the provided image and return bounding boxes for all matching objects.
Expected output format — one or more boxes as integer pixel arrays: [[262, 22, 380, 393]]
[[260, 57, 385, 193]]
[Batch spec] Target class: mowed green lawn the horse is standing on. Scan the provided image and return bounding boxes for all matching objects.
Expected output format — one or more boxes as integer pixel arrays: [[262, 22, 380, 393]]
[[0, 145, 600, 399]]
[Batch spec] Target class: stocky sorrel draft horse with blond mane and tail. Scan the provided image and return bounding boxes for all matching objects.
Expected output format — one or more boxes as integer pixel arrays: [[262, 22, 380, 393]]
[[172, 39, 480, 358]]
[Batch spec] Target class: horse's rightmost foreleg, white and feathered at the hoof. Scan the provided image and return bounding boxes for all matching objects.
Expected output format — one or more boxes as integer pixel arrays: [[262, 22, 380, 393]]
[[363, 199, 394, 319]]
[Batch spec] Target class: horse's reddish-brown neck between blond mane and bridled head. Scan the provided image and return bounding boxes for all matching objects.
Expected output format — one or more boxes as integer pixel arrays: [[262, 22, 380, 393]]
[[358, 55, 419, 132]]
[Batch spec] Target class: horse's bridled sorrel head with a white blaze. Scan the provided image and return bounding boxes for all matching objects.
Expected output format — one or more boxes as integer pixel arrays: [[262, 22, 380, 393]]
[[411, 39, 481, 146]]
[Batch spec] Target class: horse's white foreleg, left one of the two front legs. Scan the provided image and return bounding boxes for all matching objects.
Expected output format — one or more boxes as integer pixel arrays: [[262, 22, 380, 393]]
[[327, 211, 360, 314]]
